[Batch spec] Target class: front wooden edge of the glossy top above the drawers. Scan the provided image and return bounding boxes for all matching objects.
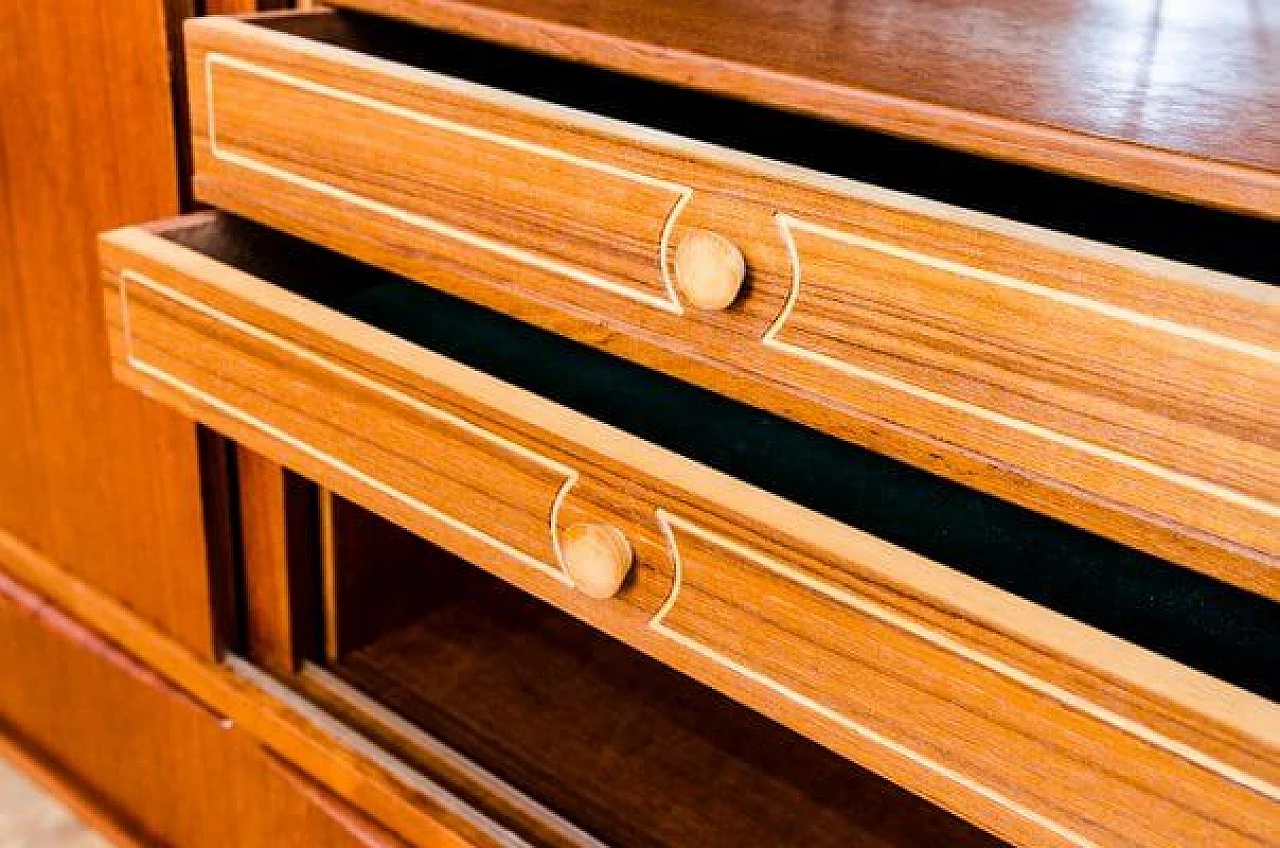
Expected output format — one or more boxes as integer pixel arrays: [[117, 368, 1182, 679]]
[[325, 0, 1280, 218]]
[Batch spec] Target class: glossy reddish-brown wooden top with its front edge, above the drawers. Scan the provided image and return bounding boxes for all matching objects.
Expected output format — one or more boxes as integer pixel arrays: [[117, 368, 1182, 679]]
[[335, 0, 1280, 218]]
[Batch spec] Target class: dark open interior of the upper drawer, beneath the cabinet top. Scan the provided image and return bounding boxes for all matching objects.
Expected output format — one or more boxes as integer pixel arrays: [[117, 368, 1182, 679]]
[[255, 12, 1280, 284]]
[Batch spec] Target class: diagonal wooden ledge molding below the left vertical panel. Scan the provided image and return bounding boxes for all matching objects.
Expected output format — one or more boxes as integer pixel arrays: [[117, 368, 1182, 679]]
[[0, 529, 521, 848]]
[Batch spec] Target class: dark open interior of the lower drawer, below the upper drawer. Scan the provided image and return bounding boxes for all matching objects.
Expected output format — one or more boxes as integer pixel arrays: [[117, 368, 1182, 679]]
[[165, 215, 1280, 699]]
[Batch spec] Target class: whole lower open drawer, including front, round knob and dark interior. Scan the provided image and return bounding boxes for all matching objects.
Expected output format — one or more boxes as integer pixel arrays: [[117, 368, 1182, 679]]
[[101, 215, 1280, 845]]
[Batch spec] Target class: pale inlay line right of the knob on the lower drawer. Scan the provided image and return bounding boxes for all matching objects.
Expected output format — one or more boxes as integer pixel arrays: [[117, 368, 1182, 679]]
[[649, 509, 1280, 821]]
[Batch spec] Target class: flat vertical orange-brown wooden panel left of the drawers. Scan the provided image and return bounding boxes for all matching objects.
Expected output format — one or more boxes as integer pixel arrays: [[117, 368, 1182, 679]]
[[0, 0, 214, 653]]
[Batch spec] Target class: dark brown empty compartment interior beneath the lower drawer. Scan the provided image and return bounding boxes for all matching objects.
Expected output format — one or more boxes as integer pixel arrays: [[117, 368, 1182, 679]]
[[312, 498, 1002, 848]]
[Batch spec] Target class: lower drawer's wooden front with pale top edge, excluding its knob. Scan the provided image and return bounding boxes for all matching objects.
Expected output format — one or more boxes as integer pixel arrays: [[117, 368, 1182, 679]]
[[102, 220, 1280, 845]]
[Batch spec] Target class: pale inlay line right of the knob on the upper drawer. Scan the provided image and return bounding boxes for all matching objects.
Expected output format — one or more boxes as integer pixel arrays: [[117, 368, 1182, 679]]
[[762, 213, 1280, 519]]
